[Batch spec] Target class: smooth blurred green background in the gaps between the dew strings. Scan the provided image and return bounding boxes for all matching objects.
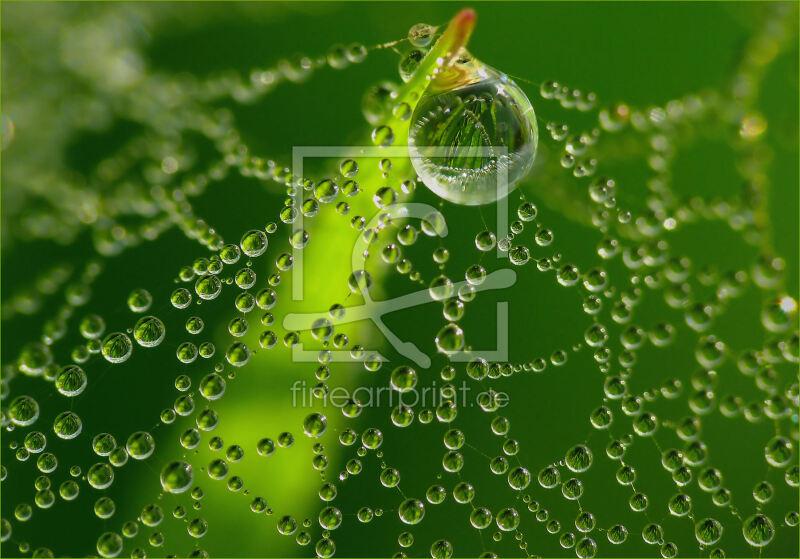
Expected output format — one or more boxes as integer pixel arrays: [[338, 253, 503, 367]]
[[0, 2, 800, 557]]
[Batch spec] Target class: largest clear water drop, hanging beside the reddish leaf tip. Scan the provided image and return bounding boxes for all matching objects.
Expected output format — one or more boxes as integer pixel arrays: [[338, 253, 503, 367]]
[[408, 49, 538, 206]]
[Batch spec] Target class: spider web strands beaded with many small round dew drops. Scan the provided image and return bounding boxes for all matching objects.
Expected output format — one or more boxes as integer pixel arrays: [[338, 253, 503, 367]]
[[2, 5, 799, 558]]
